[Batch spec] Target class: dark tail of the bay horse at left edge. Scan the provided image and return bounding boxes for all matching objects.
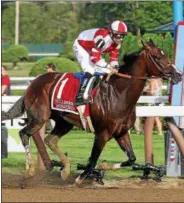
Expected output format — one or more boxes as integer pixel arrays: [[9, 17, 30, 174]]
[[1, 97, 25, 121]]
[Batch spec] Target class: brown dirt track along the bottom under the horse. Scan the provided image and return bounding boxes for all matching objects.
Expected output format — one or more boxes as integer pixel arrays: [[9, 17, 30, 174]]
[[2, 172, 184, 202]]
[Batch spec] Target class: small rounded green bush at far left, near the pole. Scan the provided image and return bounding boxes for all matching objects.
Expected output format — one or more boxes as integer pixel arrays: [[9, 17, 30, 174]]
[[2, 45, 28, 62]]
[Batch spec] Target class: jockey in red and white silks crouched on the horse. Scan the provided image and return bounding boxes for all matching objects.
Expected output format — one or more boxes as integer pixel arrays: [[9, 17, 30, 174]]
[[73, 20, 127, 106]]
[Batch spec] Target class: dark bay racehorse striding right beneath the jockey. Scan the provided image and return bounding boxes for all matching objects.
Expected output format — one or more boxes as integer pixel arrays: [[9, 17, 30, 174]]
[[2, 40, 182, 184]]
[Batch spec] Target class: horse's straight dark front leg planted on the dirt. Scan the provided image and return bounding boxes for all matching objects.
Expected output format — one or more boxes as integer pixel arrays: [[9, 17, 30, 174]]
[[75, 133, 109, 185]]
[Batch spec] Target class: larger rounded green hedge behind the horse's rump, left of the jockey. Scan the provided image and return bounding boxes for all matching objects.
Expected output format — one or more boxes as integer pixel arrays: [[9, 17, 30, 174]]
[[29, 57, 81, 76]]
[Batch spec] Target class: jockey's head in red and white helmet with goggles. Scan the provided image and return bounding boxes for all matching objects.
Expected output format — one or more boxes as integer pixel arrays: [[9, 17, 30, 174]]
[[110, 20, 127, 43]]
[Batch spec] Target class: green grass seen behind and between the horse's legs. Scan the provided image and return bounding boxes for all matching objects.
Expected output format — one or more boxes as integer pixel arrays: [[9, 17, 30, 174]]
[[2, 129, 164, 179]]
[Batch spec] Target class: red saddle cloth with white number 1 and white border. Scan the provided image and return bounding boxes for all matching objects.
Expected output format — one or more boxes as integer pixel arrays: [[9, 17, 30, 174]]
[[51, 73, 96, 116]]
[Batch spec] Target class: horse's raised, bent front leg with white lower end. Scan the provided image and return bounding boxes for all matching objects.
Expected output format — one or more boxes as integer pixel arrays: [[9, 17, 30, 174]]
[[113, 131, 136, 170]]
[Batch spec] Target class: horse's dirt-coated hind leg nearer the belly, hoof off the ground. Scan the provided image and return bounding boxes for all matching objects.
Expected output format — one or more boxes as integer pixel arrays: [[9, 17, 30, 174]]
[[44, 119, 73, 180]]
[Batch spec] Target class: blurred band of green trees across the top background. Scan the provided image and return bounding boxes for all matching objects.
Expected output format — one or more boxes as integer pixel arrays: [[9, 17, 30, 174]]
[[2, 1, 172, 47]]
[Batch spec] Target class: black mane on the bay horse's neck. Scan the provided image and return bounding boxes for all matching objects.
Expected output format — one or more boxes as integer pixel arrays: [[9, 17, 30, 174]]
[[119, 49, 142, 73]]
